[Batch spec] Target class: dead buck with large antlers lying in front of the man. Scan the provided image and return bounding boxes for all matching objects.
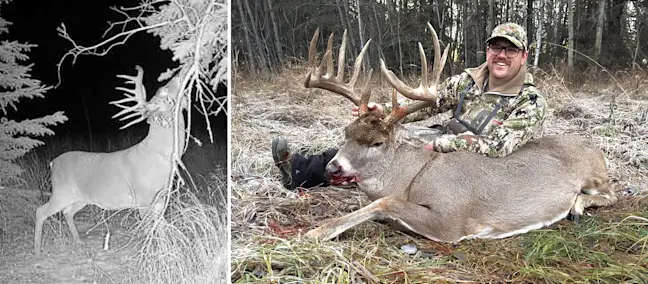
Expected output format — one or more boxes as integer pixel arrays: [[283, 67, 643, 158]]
[[305, 23, 617, 242]]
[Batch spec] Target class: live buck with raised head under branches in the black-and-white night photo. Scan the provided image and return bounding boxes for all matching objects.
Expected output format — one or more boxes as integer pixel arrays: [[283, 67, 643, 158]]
[[34, 66, 185, 255]]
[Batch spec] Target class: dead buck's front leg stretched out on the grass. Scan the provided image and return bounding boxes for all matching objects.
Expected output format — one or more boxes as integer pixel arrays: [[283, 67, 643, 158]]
[[305, 196, 451, 240]]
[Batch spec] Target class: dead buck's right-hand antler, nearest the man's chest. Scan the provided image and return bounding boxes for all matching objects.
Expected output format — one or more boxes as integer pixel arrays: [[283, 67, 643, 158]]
[[380, 23, 450, 123]]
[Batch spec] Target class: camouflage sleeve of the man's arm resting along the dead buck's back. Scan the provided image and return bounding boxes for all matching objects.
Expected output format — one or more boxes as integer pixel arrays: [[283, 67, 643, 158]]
[[432, 86, 547, 157]]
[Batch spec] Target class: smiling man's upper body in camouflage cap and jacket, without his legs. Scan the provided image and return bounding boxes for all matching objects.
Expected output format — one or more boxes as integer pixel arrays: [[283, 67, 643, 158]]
[[410, 23, 547, 157]]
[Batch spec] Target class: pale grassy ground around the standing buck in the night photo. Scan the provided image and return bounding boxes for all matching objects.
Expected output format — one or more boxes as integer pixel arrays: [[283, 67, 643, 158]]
[[0, 125, 228, 283]]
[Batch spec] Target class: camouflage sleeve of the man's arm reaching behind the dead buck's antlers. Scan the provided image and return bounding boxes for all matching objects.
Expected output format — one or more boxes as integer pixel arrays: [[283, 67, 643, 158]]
[[383, 72, 472, 123]]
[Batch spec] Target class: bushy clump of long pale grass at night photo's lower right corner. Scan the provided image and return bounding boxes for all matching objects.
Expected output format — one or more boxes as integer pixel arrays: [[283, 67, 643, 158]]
[[131, 179, 229, 283]]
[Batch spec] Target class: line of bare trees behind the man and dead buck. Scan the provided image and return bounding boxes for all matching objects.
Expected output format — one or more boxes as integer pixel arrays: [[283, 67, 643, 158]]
[[232, 0, 648, 74]]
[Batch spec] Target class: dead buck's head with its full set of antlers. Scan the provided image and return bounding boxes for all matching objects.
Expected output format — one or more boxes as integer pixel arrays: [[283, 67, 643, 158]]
[[304, 23, 449, 182]]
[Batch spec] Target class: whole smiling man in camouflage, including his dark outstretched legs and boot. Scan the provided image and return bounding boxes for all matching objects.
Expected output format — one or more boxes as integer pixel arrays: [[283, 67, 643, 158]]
[[272, 23, 547, 189]]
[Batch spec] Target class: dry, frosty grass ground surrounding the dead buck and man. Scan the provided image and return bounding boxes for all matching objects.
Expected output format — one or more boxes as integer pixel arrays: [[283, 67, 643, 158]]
[[231, 65, 648, 283]]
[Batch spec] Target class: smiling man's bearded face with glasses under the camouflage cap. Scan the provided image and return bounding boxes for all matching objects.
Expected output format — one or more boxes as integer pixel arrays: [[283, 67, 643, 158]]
[[486, 38, 529, 80]]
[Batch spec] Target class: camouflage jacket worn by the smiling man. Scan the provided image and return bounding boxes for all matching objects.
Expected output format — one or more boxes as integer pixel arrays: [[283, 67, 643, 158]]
[[385, 63, 547, 157]]
